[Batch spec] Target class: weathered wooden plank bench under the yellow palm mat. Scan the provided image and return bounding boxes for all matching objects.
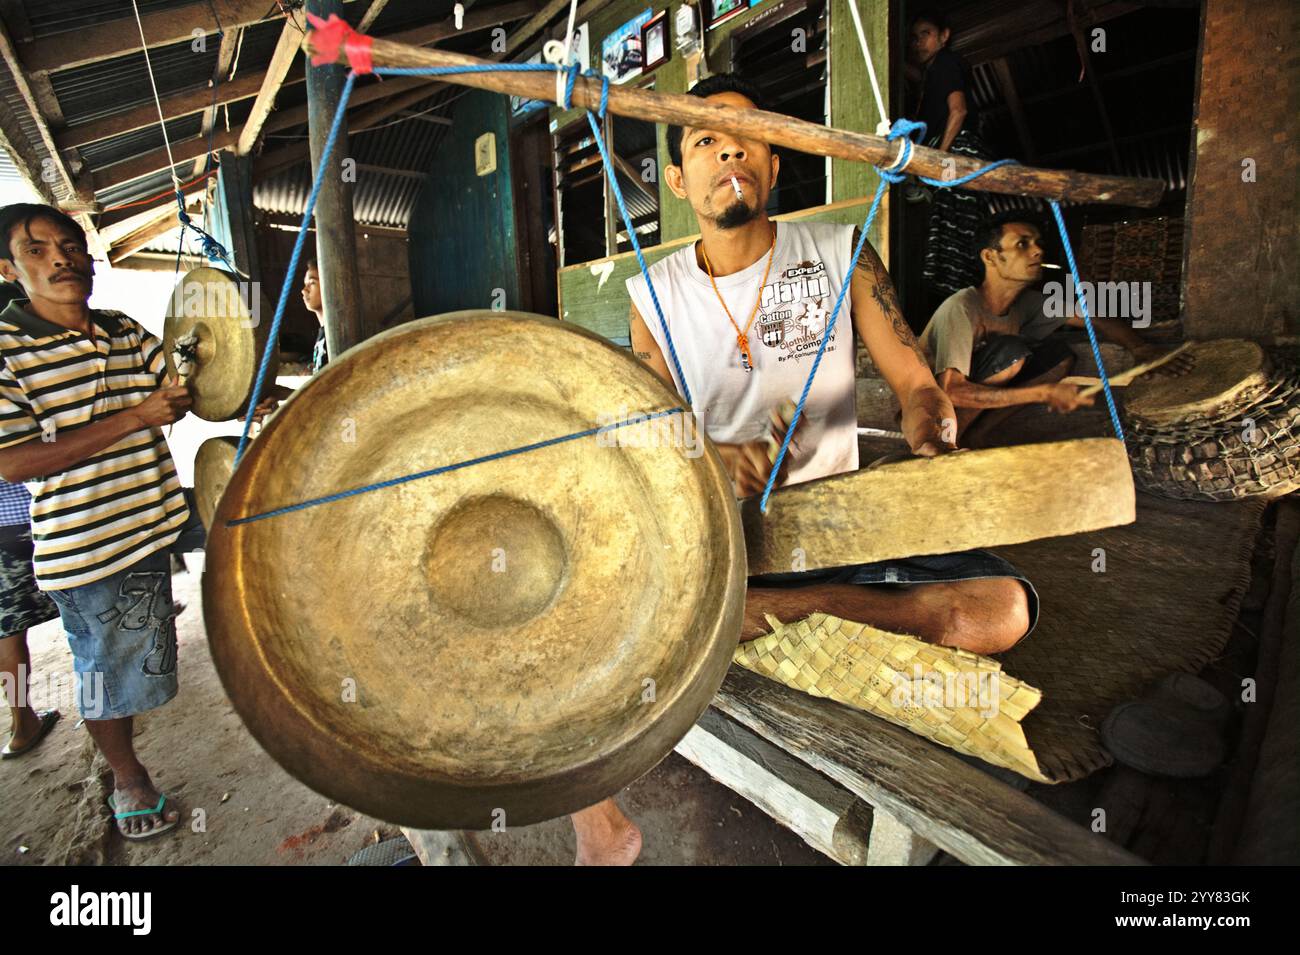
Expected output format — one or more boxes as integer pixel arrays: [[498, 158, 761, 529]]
[[677, 667, 1145, 865]]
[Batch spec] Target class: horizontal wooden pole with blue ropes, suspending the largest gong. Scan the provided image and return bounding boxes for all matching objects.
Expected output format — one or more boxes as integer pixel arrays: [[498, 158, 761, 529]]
[[322, 38, 1165, 208]]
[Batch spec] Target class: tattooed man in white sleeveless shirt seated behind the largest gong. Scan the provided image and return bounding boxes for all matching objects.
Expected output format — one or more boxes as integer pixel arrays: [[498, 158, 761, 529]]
[[573, 75, 1037, 864]]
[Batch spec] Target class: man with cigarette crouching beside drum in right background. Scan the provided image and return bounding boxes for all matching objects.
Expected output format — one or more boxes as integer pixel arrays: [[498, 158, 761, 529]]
[[920, 210, 1180, 447]]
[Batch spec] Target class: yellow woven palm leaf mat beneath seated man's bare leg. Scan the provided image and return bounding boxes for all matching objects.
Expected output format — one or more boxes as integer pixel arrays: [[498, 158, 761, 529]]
[[732, 613, 1049, 782]]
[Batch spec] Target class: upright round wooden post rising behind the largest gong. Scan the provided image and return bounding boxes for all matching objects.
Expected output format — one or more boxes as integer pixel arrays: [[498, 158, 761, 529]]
[[305, 0, 367, 355]]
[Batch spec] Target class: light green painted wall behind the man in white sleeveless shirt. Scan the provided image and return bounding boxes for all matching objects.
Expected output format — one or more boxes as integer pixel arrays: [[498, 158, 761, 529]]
[[551, 0, 889, 342]]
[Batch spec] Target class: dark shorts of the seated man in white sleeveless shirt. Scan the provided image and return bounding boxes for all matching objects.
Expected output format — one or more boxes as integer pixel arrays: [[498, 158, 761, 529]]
[[749, 551, 1039, 639]]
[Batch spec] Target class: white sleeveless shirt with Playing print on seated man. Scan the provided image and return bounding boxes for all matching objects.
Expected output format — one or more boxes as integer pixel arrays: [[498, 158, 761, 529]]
[[627, 222, 858, 485]]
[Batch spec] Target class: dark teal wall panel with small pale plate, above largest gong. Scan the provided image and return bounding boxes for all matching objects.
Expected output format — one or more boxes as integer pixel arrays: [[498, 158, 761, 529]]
[[410, 90, 520, 316]]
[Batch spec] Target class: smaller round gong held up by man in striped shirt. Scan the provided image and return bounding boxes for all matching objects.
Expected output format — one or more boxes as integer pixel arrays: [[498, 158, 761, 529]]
[[163, 268, 280, 421]]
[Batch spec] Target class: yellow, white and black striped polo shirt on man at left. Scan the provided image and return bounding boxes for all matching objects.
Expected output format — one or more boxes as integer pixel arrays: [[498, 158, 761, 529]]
[[0, 299, 189, 590]]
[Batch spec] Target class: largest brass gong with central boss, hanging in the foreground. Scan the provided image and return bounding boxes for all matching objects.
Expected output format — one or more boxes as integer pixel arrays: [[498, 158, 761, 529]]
[[203, 312, 746, 829]]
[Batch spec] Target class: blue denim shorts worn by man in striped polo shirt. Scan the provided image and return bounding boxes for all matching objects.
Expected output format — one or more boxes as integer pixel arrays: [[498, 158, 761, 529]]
[[48, 548, 177, 720]]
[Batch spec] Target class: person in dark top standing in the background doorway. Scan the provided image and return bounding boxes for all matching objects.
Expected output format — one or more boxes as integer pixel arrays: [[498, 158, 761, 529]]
[[911, 10, 991, 311]]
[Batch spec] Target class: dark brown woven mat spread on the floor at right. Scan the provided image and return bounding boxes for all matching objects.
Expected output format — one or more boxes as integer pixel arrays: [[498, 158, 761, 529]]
[[997, 492, 1265, 782]]
